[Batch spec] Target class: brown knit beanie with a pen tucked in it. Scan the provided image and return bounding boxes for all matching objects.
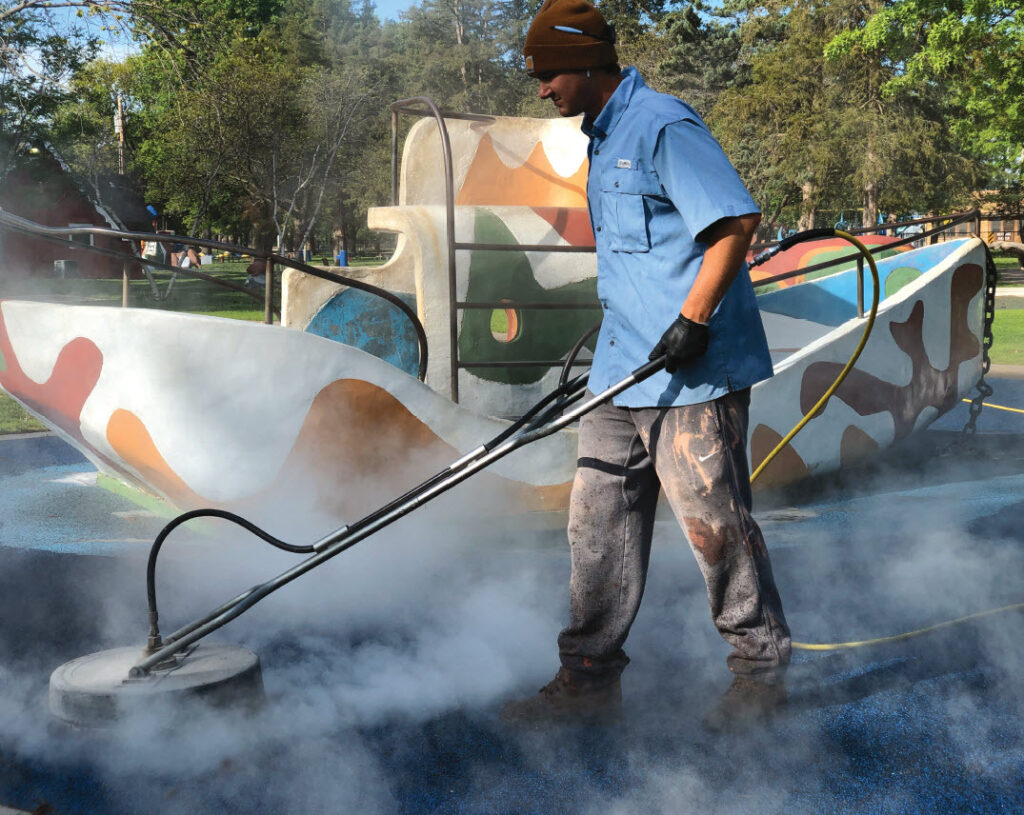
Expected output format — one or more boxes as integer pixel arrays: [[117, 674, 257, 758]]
[[522, 0, 618, 76]]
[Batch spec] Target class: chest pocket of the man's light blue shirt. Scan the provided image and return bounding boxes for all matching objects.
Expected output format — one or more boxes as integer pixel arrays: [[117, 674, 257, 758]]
[[601, 160, 665, 252]]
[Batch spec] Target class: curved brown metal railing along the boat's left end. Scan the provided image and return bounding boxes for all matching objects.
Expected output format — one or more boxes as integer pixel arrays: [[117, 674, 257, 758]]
[[0, 209, 428, 381]]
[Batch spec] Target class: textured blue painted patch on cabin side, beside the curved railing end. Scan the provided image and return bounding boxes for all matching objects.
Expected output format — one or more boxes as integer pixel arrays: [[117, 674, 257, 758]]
[[306, 289, 420, 377]]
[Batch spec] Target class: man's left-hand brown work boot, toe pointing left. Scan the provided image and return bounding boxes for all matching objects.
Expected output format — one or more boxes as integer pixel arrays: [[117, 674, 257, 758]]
[[500, 668, 623, 726]]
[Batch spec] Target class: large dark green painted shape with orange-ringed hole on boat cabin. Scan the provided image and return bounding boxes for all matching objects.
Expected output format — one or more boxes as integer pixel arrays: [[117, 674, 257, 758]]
[[459, 211, 601, 385]]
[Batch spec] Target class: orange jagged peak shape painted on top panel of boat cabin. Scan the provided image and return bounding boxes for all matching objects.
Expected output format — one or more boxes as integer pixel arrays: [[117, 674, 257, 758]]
[[456, 133, 587, 207]]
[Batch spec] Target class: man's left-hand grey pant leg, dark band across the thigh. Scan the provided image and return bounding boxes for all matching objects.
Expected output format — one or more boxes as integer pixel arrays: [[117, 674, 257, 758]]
[[558, 395, 658, 682]]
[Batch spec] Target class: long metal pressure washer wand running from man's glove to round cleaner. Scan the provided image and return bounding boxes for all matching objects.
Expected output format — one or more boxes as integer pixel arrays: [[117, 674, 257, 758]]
[[130, 356, 665, 678]]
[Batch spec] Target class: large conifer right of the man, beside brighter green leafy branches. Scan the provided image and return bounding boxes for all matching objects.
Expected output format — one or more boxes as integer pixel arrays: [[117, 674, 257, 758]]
[[710, 0, 975, 228]]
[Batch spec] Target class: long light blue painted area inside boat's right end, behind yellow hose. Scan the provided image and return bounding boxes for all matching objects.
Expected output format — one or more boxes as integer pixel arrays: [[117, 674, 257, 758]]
[[758, 239, 969, 326]]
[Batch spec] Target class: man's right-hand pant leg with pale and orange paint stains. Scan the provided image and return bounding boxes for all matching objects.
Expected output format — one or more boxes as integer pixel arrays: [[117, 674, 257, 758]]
[[640, 390, 791, 674]]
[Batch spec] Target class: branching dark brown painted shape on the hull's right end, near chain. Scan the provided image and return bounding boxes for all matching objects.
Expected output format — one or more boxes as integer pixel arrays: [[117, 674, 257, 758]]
[[800, 263, 985, 439]]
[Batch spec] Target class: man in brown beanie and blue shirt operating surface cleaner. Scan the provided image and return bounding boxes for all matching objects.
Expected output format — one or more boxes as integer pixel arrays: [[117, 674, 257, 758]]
[[502, 0, 790, 725]]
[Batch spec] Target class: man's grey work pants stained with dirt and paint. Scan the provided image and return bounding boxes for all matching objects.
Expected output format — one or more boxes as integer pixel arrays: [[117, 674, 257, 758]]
[[558, 389, 790, 683]]
